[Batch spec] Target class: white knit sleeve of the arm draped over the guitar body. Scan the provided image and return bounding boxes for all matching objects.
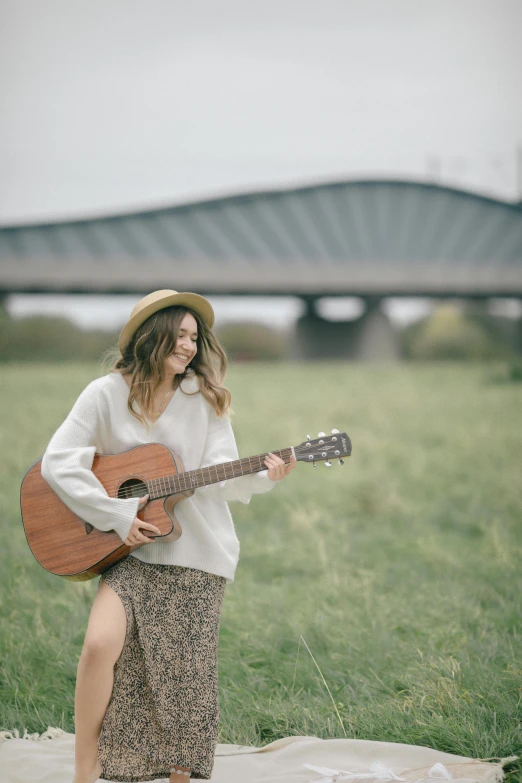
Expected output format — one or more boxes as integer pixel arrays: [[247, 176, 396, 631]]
[[41, 381, 139, 541]]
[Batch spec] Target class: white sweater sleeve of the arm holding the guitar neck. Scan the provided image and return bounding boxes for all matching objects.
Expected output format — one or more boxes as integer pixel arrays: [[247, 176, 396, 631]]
[[196, 409, 276, 504]]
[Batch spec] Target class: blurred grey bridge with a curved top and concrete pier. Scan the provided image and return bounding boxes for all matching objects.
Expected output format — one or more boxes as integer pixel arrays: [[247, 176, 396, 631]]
[[0, 180, 522, 355]]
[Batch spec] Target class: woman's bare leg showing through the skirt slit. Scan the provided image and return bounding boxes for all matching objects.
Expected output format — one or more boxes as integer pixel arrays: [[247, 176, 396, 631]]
[[73, 580, 126, 783]]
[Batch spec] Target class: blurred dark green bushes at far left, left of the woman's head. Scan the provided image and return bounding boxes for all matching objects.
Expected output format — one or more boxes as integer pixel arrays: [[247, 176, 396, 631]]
[[0, 315, 116, 362]]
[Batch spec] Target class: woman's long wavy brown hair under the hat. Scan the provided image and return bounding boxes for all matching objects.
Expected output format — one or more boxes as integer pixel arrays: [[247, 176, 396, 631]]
[[111, 305, 231, 426]]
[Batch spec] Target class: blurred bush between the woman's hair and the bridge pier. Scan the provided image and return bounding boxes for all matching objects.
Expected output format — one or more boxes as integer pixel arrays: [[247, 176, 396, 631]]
[[216, 321, 287, 360]]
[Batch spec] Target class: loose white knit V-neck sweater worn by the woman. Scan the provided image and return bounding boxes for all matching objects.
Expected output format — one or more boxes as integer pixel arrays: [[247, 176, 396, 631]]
[[42, 371, 275, 582]]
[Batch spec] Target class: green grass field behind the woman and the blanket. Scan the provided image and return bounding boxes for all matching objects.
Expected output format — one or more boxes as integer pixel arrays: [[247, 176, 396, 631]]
[[0, 362, 522, 780]]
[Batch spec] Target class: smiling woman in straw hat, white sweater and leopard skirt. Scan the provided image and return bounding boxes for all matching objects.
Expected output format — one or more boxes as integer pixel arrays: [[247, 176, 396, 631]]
[[42, 290, 296, 783]]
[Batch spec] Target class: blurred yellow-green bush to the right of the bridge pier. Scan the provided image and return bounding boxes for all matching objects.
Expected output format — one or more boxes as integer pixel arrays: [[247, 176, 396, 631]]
[[401, 304, 514, 360]]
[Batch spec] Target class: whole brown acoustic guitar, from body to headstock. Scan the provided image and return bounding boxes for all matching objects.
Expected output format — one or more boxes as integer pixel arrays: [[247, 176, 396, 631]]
[[20, 429, 352, 581]]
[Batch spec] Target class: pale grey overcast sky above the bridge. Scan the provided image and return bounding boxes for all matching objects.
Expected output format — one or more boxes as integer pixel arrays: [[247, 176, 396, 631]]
[[0, 0, 522, 328]]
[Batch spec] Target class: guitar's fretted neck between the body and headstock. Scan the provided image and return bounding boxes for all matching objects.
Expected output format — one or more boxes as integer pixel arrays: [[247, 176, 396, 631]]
[[147, 447, 292, 500]]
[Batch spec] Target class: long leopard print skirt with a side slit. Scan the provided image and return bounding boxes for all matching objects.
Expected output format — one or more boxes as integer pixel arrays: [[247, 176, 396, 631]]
[[99, 557, 226, 782]]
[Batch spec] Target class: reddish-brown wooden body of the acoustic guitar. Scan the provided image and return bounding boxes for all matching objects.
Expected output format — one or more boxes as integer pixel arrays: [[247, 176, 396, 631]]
[[20, 443, 194, 581]]
